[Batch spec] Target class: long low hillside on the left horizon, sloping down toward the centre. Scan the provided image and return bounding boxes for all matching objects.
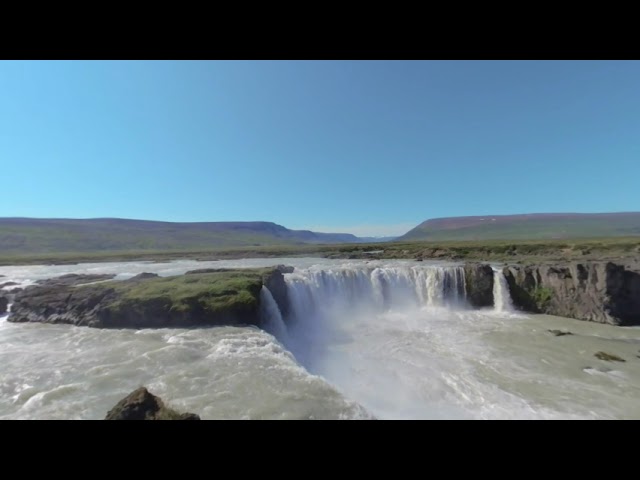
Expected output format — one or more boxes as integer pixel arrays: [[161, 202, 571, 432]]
[[0, 218, 359, 254]]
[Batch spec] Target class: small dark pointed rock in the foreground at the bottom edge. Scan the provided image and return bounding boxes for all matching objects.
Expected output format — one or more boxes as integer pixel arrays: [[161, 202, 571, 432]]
[[105, 387, 200, 420]]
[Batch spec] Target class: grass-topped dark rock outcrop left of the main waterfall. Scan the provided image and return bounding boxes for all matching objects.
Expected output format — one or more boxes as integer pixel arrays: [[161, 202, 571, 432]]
[[8, 267, 286, 328]]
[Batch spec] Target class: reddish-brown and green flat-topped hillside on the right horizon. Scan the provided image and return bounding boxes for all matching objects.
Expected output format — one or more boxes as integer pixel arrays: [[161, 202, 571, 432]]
[[398, 212, 640, 241]]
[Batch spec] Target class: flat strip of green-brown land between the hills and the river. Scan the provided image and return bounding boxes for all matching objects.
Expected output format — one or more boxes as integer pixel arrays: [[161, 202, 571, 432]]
[[0, 237, 640, 265]]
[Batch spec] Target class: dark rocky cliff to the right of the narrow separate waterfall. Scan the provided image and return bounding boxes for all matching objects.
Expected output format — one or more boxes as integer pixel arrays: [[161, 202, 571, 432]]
[[503, 262, 640, 325]]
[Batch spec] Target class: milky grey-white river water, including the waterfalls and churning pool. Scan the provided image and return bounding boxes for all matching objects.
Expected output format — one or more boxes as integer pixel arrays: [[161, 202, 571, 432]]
[[0, 258, 640, 419]]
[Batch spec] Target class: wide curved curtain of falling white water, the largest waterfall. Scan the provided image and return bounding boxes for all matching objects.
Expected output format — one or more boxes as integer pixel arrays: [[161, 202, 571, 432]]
[[278, 265, 465, 371]]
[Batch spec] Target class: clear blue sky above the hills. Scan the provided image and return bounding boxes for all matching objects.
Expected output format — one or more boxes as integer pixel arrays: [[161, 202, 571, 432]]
[[0, 61, 640, 235]]
